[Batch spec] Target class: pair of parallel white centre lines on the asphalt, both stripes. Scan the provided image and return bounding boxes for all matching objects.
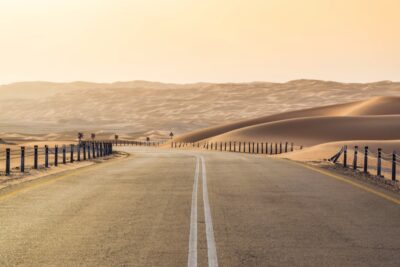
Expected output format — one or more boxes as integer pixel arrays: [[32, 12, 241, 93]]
[[188, 156, 218, 267]]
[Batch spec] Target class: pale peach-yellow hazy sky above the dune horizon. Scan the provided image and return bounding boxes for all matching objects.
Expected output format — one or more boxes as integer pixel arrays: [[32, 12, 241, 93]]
[[0, 0, 400, 83]]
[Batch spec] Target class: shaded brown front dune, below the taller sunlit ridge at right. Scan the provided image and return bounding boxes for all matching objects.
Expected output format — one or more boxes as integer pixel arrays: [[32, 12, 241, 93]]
[[210, 115, 400, 146]]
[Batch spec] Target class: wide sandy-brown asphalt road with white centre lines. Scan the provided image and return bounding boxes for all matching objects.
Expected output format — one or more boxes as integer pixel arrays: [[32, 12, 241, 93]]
[[0, 147, 400, 266]]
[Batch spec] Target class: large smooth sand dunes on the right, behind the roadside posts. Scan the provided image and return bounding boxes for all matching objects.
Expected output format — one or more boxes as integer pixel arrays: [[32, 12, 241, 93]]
[[176, 97, 400, 145]]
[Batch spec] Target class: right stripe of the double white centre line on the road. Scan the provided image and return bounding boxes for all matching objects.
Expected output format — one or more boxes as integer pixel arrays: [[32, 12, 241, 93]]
[[201, 156, 218, 267]]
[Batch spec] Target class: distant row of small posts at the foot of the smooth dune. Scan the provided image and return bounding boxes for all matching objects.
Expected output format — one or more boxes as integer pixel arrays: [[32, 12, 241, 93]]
[[171, 141, 303, 155]]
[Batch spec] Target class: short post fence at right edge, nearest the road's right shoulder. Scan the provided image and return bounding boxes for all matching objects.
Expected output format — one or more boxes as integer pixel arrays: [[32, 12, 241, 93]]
[[329, 146, 400, 182]]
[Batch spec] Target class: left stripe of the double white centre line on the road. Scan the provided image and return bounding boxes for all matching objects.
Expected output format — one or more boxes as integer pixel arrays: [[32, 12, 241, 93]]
[[188, 157, 200, 267]]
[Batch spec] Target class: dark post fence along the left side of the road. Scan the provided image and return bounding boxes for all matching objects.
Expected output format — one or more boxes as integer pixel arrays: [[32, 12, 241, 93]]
[[0, 141, 113, 176]]
